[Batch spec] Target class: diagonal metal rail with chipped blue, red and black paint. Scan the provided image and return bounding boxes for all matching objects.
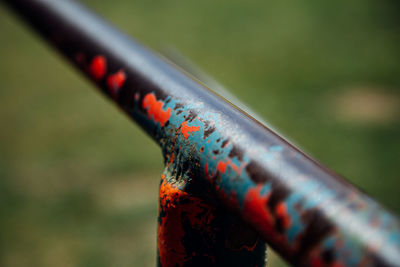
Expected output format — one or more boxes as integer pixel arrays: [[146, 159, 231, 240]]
[[5, 0, 400, 266]]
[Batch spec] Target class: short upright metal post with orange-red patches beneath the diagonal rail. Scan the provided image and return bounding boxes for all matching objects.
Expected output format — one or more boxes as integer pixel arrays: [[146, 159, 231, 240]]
[[157, 170, 266, 267]]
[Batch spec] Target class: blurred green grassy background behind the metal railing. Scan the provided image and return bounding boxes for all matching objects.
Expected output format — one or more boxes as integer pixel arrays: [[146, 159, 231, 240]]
[[0, 0, 400, 267]]
